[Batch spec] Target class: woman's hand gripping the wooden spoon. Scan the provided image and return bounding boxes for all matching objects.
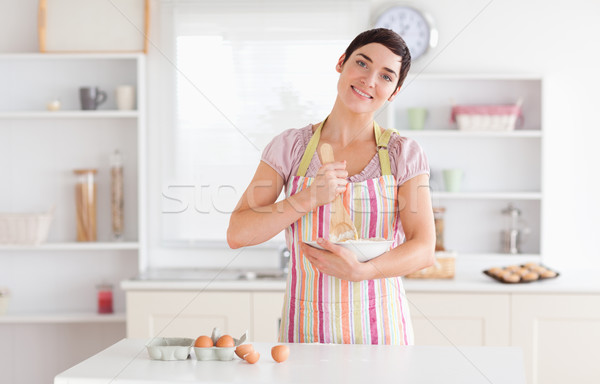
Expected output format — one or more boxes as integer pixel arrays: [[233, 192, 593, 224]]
[[308, 161, 348, 207]]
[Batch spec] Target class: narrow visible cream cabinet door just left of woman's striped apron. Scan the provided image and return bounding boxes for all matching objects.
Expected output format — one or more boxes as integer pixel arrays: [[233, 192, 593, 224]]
[[252, 291, 284, 343]]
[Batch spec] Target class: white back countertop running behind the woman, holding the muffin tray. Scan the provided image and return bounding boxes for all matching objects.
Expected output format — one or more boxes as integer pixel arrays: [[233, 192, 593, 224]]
[[121, 263, 600, 294]]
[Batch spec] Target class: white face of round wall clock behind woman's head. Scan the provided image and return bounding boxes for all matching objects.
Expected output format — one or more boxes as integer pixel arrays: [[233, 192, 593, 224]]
[[375, 6, 433, 60]]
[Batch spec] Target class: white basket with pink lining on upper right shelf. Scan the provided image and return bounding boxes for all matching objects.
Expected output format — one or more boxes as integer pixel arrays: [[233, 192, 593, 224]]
[[451, 100, 522, 131]]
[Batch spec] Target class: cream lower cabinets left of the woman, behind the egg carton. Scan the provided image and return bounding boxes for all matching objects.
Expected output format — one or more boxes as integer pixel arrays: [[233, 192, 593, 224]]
[[127, 291, 283, 342]]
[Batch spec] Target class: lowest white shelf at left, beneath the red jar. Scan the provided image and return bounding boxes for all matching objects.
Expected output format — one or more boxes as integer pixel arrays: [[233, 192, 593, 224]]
[[0, 312, 125, 324]]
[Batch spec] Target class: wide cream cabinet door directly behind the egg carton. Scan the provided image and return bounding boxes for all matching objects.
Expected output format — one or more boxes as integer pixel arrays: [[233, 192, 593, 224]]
[[127, 291, 251, 338]]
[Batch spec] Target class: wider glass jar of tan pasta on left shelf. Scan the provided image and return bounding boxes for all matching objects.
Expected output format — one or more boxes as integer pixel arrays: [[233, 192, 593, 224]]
[[73, 169, 98, 241]]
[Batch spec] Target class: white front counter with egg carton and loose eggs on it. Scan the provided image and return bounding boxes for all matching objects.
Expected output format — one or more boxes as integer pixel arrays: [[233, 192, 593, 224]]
[[54, 339, 525, 384]]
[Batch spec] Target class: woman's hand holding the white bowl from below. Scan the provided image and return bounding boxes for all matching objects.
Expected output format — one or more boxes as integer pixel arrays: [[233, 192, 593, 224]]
[[301, 239, 365, 281]]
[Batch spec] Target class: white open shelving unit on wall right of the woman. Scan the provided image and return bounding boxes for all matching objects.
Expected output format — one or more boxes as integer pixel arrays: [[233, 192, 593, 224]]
[[378, 74, 543, 259]]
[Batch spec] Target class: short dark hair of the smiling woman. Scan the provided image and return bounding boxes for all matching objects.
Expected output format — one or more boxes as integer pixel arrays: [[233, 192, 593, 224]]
[[342, 28, 411, 92]]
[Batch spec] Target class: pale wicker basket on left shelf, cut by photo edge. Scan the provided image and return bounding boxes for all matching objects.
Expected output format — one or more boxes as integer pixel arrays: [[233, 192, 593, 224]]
[[0, 208, 54, 245]]
